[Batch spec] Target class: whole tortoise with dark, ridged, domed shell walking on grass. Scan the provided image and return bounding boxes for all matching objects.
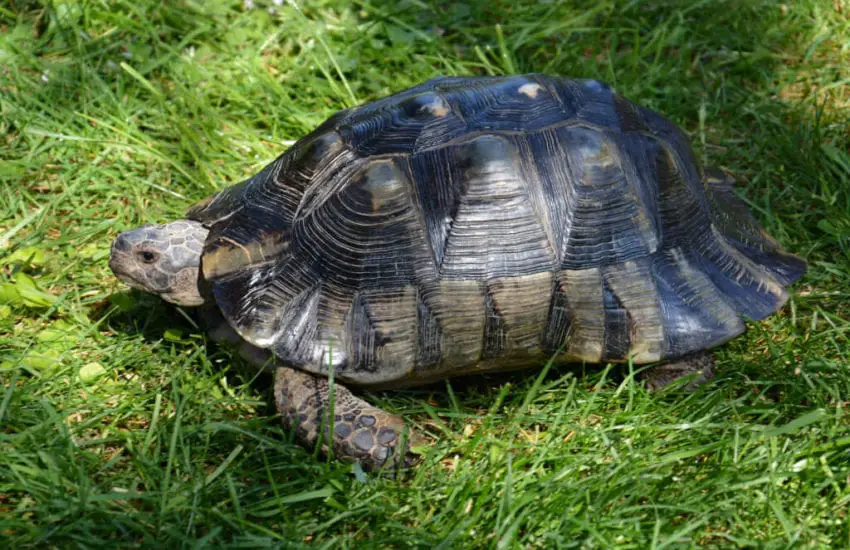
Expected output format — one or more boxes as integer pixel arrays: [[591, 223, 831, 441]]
[[110, 74, 806, 469]]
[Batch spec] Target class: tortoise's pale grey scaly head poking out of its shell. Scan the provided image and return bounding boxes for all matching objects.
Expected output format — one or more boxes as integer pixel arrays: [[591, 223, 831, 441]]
[[109, 220, 209, 306]]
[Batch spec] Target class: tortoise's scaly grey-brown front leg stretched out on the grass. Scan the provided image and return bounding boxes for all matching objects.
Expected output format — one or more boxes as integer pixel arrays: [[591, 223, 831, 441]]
[[274, 367, 421, 471]]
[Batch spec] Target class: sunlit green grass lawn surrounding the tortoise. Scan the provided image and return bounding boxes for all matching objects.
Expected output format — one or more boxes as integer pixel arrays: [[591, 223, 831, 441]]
[[0, 0, 850, 549]]
